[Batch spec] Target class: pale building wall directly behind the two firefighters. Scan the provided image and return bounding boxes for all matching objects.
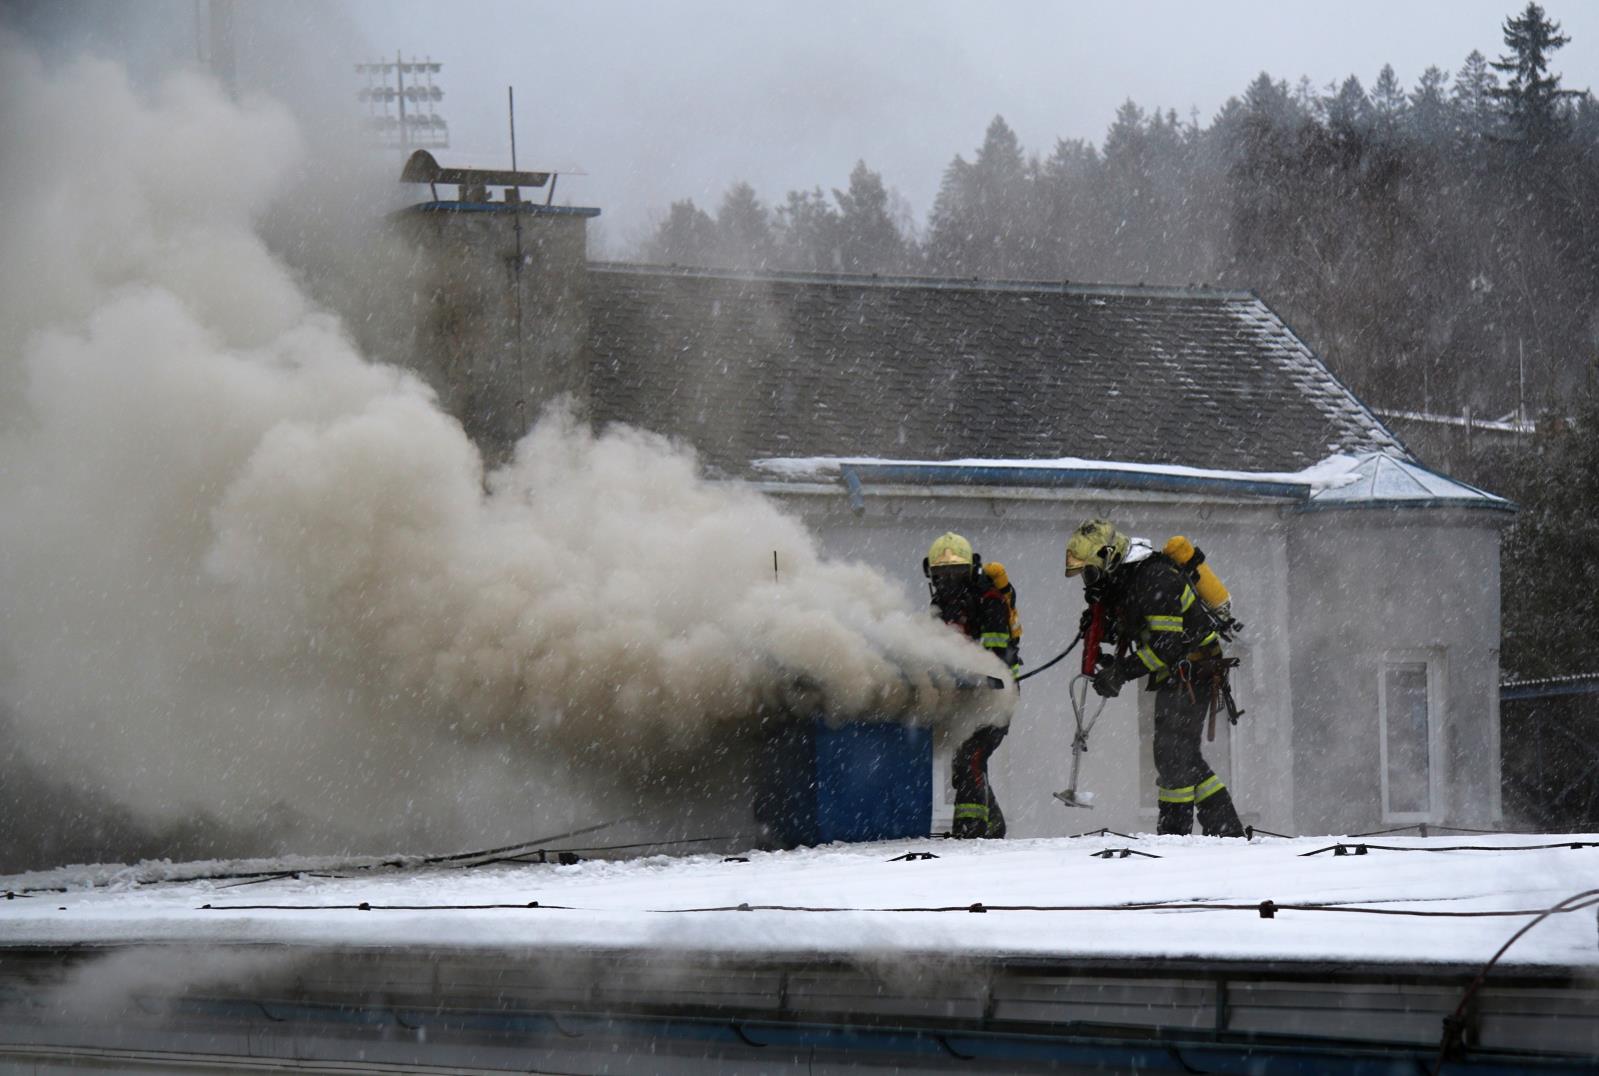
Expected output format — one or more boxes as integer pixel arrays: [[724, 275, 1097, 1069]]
[[761, 489, 1294, 836]]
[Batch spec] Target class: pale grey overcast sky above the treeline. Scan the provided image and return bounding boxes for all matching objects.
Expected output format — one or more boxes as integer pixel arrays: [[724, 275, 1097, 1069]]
[[12, 0, 1599, 248]]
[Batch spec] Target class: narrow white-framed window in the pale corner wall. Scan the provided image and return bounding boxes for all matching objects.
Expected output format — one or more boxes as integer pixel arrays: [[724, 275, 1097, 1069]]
[[1377, 652, 1442, 822]]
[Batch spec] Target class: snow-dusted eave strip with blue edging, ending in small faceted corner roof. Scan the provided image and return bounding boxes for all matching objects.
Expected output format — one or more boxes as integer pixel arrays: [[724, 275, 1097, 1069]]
[[755, 452, 1514, 512]]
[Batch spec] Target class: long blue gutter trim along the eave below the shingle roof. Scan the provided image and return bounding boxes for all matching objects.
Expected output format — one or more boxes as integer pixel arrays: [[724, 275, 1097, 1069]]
[[841, 464, 1308, 500]]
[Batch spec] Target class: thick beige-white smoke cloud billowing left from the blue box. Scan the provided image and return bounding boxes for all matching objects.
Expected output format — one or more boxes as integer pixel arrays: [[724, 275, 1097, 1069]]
[[0, 42, 1014, 847]]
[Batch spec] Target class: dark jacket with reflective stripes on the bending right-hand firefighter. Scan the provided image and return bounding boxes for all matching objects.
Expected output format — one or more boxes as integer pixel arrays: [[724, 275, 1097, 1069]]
[[1103, 553, 1222, 687]]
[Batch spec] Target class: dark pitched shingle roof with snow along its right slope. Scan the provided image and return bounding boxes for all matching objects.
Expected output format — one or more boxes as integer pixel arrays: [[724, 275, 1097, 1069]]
[[588, 264, 1404, 472]]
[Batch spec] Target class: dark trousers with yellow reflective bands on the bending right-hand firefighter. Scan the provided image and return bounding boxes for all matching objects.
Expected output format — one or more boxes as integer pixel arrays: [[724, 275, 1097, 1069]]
[[1154, 684, 1244, 836]]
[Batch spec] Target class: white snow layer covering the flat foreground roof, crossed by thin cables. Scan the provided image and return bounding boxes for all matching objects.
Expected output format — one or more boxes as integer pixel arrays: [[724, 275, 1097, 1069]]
[[0, 835, 1599, 966]]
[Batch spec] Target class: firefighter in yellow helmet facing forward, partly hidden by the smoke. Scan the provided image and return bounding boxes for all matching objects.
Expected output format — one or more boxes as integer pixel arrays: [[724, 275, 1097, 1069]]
[[921, 532, 1020, 838]]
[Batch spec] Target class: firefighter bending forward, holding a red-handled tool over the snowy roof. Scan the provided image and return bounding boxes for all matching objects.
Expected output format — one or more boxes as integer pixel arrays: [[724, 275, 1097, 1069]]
[[1067, 520, 1244, 836]]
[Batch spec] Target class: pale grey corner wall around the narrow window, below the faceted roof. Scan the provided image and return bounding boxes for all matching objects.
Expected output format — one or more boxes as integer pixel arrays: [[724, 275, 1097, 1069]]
[[1289, 510, 1506, 833]]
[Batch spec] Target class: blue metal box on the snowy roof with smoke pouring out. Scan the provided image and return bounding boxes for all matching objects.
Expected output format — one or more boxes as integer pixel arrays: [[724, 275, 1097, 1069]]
[[755, 718, 932, 847]]
